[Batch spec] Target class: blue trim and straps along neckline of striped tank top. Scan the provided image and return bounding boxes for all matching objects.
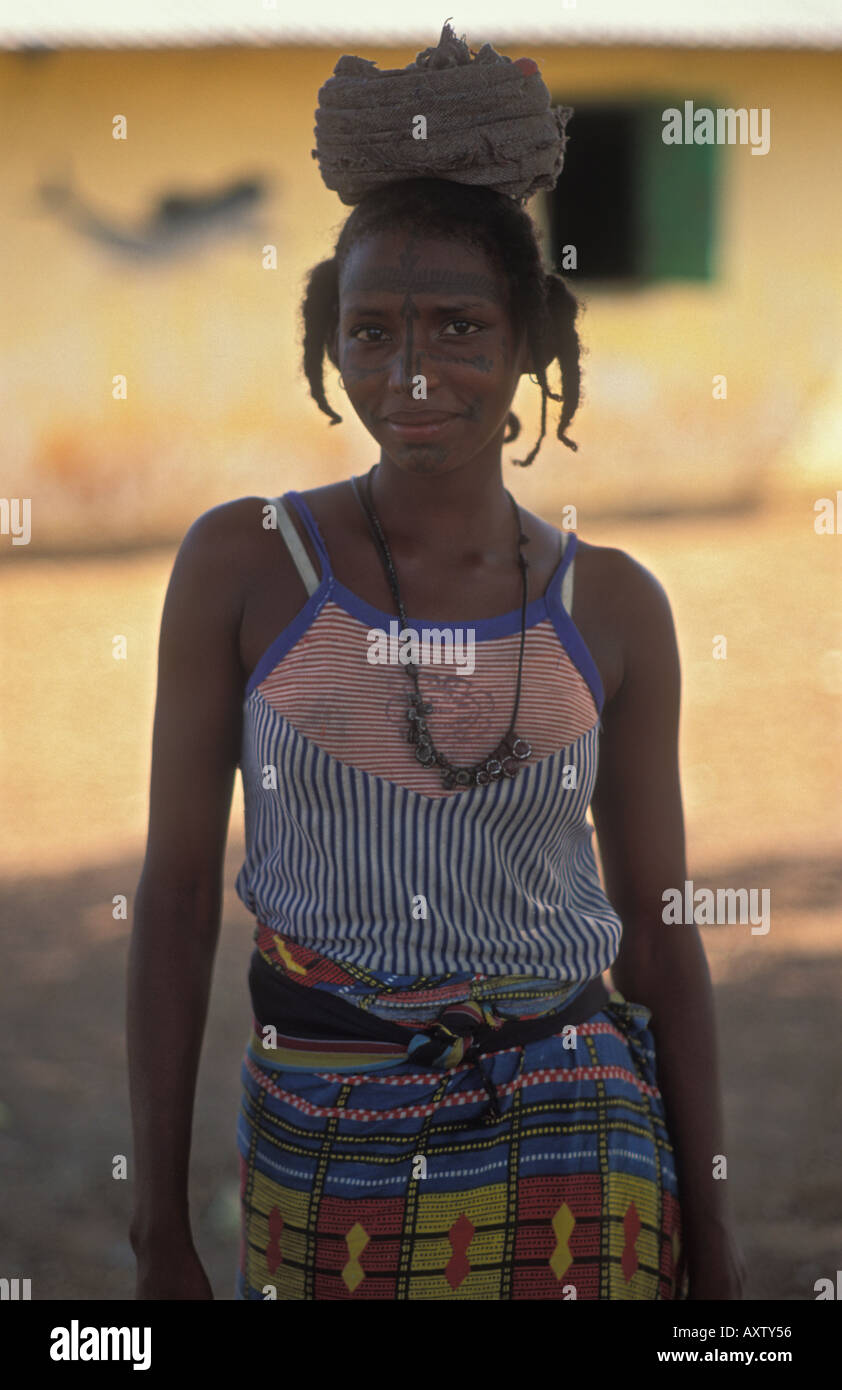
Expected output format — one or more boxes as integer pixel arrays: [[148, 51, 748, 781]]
[[246, 489, 604, 716]]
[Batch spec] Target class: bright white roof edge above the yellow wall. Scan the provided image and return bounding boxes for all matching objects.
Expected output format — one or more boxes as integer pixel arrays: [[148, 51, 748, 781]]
[[0, 13, 842, 56]]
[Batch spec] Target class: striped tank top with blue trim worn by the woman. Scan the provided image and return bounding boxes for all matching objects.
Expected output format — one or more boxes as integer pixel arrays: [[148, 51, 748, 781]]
[[236, 492, 622, 1006]]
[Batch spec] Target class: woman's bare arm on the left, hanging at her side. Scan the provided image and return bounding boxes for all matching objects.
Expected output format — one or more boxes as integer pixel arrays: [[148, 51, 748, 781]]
[[128, 503, 243, 1298]]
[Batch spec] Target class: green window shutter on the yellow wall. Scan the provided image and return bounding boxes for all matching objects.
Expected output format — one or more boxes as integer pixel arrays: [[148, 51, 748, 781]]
[[634, 95, 721, 281]]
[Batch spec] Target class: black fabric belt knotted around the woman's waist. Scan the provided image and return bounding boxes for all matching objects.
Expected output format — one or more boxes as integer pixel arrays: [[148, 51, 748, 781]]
[[249, 949, 610, 1119]]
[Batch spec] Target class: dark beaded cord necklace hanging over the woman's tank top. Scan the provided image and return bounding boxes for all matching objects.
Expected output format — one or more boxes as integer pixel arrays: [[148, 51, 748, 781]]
[[352, 464, 532, 791]]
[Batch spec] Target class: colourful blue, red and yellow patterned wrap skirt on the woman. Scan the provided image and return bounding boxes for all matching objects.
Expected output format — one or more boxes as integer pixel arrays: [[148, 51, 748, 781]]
[[236, 924, 688, 1301]]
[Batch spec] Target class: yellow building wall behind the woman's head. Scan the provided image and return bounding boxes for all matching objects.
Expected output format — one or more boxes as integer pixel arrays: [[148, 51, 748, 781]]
[[0, 36, 842, 549]]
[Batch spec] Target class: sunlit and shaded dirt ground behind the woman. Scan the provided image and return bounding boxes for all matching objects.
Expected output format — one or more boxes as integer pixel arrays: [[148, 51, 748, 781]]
[[0, 500, 842, 1300]]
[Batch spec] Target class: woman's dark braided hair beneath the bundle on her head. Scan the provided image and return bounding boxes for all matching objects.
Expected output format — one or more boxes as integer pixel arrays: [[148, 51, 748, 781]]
[[302, 178, 581, 468]]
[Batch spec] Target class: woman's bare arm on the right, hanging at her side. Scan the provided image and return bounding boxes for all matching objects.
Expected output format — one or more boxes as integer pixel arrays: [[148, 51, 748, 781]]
[[592, 552, 745, 1298]]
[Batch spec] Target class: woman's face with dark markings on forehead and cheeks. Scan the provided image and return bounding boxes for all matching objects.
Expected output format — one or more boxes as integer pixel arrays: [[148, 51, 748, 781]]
[[333, 231, 528, 473]]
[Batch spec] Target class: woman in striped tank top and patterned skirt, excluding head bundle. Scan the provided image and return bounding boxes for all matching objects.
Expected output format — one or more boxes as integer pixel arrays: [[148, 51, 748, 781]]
[[129, 29, 743, 1300]]
